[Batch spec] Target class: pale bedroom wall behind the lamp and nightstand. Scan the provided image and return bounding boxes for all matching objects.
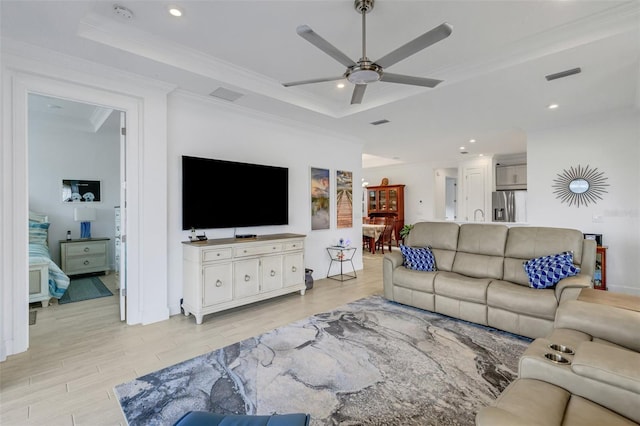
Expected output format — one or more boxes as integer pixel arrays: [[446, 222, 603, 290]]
[[28, 111, 120, 269]]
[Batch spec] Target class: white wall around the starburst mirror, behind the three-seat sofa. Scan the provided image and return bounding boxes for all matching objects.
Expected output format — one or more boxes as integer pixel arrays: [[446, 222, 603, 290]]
[[527, 109, 640, 294]]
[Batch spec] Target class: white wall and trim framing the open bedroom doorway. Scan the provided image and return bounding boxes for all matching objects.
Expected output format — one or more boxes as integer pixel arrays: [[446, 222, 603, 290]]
[[0, 44, 173, 361]]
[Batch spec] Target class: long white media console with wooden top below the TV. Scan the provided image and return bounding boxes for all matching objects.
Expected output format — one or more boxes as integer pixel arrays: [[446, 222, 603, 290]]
[[182, 234, 306, 324]]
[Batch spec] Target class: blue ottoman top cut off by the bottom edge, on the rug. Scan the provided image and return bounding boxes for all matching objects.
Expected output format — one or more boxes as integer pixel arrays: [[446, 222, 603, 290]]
[[174, 411, 311, 426]]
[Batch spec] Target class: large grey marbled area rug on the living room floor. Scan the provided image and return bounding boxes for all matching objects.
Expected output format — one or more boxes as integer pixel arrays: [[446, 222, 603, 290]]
[[115, 296, 531, 426]]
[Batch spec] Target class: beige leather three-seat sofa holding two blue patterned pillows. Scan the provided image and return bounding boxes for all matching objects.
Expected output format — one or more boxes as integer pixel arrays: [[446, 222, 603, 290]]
[[383, 222, 596, 338]]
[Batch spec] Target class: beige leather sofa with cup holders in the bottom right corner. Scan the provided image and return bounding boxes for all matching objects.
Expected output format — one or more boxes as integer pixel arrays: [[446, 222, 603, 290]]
[[476, 300, 640, 426]]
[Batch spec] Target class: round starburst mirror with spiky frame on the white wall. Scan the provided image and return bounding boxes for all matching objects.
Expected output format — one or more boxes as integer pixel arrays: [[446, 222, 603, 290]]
[[551, 165, 609, 207]]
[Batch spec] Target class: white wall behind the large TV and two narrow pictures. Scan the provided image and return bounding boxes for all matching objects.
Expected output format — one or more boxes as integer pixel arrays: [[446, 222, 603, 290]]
[[168, 92, 362, 314]]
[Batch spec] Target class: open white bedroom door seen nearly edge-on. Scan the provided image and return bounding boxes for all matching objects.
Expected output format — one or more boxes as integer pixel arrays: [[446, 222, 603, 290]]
[[116, 112, 127, 321]]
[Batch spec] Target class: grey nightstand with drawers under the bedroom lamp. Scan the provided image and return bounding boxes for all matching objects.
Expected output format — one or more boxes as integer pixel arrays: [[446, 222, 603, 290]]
[[60, 238, 109, 275]]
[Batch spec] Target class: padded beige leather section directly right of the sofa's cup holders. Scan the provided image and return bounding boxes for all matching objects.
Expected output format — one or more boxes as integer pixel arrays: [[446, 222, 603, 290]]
[[571, 342, 640, 395]]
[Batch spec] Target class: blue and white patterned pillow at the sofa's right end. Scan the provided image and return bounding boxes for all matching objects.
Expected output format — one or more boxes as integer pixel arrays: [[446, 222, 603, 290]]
[[523, 251, 580, 288]]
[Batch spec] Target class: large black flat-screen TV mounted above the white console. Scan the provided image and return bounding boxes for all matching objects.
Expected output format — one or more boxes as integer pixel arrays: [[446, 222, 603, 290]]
[[182, 155, 289, 230]]
